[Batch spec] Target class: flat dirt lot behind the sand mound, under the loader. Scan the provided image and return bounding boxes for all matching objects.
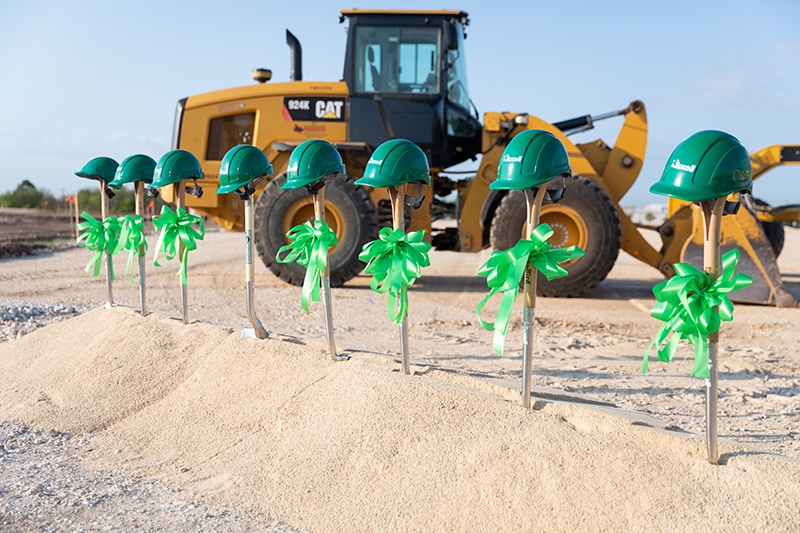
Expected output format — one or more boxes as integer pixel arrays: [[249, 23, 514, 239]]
[[0, 219, 800, 458]]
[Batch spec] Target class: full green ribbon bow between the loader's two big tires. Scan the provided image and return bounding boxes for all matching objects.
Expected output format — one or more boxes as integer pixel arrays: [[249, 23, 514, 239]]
[[358, 228, 431, 324]]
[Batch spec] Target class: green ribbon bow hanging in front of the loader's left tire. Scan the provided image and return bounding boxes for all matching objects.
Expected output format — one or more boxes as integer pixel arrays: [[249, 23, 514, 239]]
[[275, 220, 339, 312]]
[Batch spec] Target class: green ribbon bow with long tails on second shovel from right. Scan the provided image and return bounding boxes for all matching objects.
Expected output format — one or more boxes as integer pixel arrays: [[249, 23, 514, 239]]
[[476, 224, 583, 355]]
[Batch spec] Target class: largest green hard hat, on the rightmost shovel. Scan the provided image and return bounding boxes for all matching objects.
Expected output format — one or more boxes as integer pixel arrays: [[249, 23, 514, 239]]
[[650, 130, 753, 202]]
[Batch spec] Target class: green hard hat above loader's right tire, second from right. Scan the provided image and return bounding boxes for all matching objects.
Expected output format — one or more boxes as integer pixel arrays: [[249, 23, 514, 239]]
[[489, 130, 572, 190]]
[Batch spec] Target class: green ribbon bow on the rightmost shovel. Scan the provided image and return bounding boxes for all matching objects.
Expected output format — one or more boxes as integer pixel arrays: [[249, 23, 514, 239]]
[[642, 249, 753, 378]]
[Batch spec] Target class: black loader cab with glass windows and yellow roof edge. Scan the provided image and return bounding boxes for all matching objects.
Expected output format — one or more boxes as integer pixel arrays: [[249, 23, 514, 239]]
[[340, 9, 481, 168]]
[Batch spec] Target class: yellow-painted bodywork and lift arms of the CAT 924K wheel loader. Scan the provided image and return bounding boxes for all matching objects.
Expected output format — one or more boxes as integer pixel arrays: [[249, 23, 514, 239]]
[[164, 10, 800, 306]]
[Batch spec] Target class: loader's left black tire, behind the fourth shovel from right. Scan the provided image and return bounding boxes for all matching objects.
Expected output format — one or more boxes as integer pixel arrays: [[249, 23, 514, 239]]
[[254, 174, 378, 287]]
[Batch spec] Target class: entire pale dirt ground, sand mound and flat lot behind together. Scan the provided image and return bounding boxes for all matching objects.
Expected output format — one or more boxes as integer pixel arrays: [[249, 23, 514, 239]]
[[0, 218, 800, 532]]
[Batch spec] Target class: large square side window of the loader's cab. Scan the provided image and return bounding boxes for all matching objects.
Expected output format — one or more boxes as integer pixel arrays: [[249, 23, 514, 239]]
[[354, 26, 440, 94]]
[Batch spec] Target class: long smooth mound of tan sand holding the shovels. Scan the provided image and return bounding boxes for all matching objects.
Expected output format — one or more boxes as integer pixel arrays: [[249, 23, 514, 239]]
[[0, 309, 800, 531]]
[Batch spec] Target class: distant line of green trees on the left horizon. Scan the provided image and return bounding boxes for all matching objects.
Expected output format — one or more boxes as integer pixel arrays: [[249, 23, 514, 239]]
[[0, 180, 165, 213]]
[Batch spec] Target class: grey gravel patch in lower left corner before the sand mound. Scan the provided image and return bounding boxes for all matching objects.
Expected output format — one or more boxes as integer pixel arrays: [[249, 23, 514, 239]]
[[0, 422, 308, 533]]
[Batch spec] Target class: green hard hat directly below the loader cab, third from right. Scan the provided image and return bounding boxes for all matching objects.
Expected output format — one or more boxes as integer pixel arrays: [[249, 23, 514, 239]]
[[356, 139, 431, 187]]
